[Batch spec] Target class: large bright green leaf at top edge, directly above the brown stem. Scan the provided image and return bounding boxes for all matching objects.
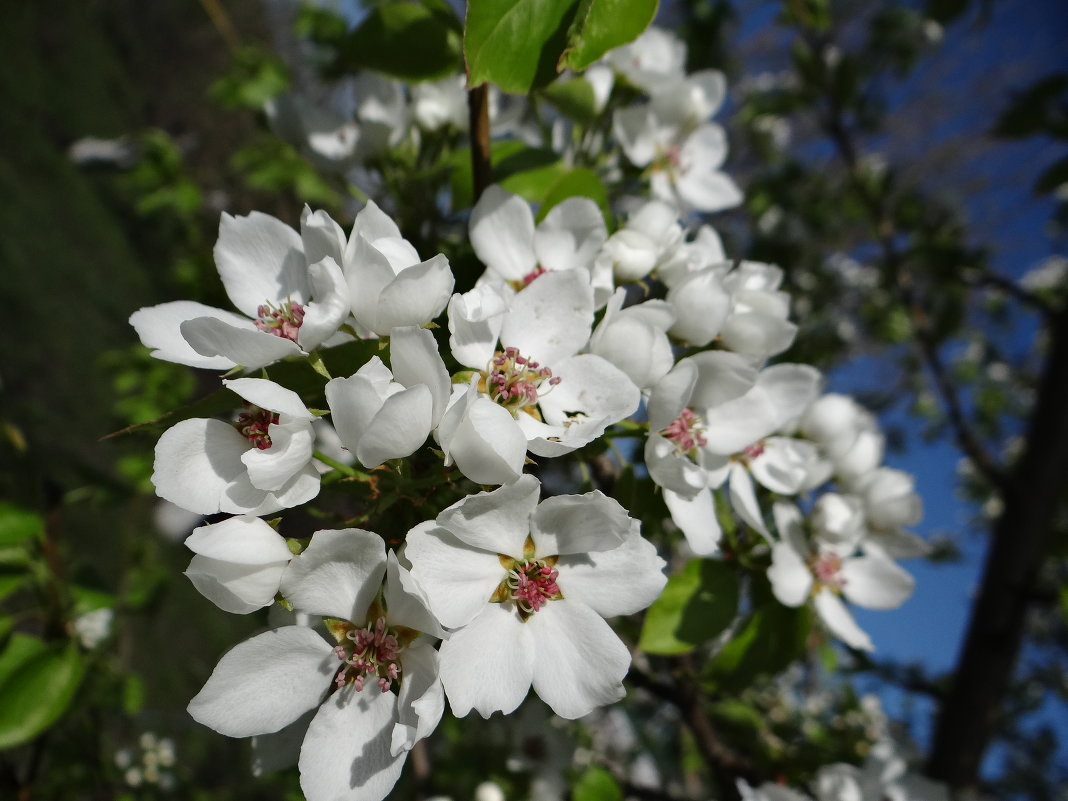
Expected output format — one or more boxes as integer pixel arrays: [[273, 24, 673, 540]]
[[464, 0, 579, 95]]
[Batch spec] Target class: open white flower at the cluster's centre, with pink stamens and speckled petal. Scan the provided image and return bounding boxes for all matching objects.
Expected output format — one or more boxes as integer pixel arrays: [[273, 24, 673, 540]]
[[437, 270, 640, 484]]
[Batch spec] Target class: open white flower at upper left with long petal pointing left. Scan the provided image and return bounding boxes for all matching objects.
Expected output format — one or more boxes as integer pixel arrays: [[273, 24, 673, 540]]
[[130, 213, 349, 370]]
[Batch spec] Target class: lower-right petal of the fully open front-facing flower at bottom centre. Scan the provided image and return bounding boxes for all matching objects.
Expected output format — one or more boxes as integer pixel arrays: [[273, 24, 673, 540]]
[[527, 599, 630, 720]]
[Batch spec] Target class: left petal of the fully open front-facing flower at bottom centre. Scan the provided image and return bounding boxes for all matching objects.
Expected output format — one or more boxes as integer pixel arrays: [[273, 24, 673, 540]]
[[405, 521, 505, 628]]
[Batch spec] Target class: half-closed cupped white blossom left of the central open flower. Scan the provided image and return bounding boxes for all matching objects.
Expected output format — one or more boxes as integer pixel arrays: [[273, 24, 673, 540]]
[[326, 327, 450, 468]]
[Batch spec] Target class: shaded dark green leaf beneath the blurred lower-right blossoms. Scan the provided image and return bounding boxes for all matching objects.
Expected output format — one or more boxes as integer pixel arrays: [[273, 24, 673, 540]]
[[705, 601, 812, 690]]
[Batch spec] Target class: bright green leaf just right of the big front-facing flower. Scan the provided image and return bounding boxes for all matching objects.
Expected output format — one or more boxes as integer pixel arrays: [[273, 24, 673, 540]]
[[638, 559, 738, 655]]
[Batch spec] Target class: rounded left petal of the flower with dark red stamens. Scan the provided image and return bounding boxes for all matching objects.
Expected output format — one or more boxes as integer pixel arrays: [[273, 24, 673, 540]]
[[152, 418, 251, 515]]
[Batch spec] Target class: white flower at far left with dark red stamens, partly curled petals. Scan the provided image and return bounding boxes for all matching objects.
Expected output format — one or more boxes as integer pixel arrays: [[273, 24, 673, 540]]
[[152, 378, 319, 515]]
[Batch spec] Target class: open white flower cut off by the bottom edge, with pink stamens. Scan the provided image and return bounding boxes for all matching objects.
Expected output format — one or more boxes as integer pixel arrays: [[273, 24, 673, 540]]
[[189, 529, 444, 801]]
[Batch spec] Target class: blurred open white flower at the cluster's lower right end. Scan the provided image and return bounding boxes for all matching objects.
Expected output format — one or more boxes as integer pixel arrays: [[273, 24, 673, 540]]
[[768, 501, 915, 650]]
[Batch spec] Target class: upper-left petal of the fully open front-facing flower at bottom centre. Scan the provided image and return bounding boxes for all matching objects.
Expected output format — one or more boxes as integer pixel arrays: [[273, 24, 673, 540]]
[[437, 474, 538, 557]]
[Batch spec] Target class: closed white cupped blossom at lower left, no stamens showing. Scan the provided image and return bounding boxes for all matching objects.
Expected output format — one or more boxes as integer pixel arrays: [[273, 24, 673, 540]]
[[186, 515, 293, 614]]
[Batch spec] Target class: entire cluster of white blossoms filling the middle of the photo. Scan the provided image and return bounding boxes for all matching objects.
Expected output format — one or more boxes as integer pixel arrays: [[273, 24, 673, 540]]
[[130, 23, 923, 801]]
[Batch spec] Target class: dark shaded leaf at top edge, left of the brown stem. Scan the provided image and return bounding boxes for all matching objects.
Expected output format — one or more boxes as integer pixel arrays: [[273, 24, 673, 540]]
[[339, 0, 462, 81]]
